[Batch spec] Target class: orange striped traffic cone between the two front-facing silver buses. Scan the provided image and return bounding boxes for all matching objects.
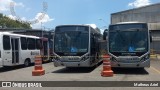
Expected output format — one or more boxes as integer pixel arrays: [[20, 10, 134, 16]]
[[101, 55, 113, 77]]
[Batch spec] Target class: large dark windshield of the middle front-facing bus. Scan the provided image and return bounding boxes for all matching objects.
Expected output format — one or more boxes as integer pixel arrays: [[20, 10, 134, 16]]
[[54, 27, 89, 54]]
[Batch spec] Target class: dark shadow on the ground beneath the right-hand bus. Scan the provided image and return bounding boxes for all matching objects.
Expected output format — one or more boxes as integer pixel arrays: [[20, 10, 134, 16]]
[[112, 68, 149, 75]]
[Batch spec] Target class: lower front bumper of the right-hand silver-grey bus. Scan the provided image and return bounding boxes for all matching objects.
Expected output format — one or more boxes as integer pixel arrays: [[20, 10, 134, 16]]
[[111, 59, 150, 68]]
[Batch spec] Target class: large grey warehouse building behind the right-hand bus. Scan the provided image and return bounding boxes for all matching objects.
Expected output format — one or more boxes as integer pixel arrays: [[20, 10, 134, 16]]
[[111, 3, 160, 53]]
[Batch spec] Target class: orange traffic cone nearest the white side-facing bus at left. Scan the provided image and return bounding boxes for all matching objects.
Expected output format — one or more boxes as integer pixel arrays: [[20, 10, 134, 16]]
[[32, 56, 45, 76]]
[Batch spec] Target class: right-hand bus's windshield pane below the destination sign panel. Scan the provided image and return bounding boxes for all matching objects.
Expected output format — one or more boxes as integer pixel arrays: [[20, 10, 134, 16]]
[[109, 31, 148, 52]]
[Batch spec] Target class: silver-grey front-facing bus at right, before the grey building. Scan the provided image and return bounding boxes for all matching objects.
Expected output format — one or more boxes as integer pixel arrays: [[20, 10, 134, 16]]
[[104, 22, 151, 68]]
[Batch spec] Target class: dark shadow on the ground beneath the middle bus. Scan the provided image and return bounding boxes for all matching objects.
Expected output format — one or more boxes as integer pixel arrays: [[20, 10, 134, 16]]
[[52, 62, 102, 74]]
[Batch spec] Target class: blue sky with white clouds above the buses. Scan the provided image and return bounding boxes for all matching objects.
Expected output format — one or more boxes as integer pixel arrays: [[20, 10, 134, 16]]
[[0, 0, 160, 30]]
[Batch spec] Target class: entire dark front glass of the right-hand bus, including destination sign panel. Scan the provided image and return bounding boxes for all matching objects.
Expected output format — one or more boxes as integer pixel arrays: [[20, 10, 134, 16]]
[[109, 24, 148, 53]]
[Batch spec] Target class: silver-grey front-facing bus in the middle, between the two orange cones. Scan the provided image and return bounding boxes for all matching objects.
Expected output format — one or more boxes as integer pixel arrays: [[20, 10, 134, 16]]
[[53, 24, 102, 67]]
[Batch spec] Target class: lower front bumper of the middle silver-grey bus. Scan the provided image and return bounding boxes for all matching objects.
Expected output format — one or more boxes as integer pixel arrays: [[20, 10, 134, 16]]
[[54, 60, 92, 67]]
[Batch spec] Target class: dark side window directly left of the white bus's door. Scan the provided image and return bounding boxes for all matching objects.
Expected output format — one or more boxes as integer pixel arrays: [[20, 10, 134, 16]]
[[3, 35, 11, 50]]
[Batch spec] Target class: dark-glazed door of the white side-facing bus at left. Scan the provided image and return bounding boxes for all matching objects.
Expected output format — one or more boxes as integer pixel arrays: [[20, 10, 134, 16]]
[[11, 38, 19, 64]]
